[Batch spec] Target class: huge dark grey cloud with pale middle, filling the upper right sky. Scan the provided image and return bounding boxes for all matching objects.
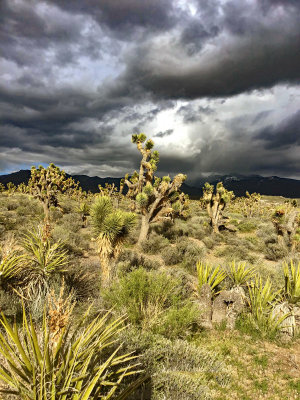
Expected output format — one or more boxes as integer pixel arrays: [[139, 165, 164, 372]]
[[113, 1, 300, 99]]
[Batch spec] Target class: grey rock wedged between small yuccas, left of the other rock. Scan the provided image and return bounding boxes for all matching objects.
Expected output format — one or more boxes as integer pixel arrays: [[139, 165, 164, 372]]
[[212, 287, 245, 329]]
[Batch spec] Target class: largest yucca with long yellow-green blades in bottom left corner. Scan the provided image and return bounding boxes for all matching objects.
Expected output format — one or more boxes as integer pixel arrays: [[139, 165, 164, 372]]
[[0, 307, 144, 400]]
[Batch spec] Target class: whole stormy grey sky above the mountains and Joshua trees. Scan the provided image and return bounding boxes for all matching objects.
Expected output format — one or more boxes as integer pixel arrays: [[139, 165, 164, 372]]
[[0, 0, 300, 181]]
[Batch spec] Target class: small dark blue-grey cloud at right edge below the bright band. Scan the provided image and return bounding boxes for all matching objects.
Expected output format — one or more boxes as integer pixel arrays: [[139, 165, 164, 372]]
[[256, 111, 300, 149]]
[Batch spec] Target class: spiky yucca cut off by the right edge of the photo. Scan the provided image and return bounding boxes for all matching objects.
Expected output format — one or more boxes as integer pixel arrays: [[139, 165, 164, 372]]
[[283, 260, 300, 304]]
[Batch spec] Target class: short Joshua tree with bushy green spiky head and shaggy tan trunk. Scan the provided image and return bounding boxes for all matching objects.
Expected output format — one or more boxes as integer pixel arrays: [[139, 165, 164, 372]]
[[90, 196, 136, 286]]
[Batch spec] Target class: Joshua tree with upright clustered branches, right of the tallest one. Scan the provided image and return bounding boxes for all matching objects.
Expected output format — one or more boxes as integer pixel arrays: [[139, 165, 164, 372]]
[[203, 182, 234, 233]]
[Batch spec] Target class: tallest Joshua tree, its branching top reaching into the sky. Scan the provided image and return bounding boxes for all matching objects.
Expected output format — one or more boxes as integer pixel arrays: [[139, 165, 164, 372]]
[[121, 133, 188, 244]]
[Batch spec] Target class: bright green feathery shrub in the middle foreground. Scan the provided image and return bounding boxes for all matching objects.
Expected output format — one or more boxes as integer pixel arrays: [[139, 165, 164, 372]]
[[103, 268, 198, 336]]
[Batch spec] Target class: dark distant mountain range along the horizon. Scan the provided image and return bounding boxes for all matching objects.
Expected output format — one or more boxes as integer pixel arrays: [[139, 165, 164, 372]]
[[0, 170, 300, 198]]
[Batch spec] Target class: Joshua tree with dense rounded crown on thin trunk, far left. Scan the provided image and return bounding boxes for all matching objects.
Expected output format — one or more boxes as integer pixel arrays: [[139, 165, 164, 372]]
[[28, 164, 75, 234]]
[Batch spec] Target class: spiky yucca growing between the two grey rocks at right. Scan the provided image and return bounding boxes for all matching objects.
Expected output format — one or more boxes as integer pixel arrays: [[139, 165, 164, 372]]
[[248, 276, 289, 335]]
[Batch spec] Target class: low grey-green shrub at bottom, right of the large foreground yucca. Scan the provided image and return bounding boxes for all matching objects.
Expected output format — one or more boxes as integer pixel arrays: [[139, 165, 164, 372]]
[[122, 330, 230, 400]]
